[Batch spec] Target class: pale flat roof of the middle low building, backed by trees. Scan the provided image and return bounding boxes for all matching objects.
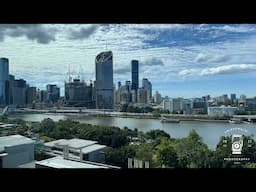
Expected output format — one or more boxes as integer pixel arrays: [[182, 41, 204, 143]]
[[45, 138, 97, 149]]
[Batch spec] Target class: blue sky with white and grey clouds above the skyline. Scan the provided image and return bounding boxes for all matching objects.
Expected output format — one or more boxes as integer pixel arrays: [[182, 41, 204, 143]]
[[0, 24, 256, 98]]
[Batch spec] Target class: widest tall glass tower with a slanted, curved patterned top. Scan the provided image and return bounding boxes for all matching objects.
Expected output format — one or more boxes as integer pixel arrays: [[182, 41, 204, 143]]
[[95, 51, 114, 109]]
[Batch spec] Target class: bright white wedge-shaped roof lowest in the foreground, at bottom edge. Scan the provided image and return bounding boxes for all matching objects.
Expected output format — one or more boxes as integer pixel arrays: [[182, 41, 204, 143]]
[[36, 156, 109, 169]]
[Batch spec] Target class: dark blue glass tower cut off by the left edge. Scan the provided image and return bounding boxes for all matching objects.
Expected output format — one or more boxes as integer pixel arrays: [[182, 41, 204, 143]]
[[0, 58, 9, 105]]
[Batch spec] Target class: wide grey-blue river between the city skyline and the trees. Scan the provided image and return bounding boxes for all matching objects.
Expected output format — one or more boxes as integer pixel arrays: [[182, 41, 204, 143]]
[[9, 113, 256, 149]]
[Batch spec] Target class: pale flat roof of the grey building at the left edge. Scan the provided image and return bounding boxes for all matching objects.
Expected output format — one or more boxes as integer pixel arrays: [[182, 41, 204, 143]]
[[0, 135, 35, 152]]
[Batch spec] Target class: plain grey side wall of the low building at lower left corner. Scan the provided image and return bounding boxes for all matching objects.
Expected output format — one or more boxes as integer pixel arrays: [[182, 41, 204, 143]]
[[2, 143, 34, 168]]
